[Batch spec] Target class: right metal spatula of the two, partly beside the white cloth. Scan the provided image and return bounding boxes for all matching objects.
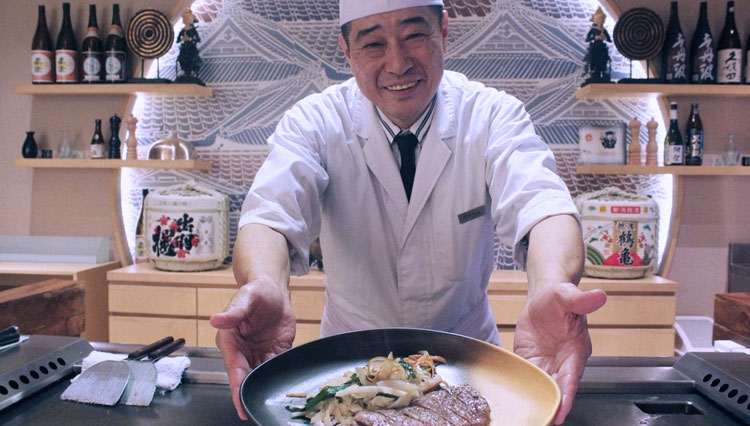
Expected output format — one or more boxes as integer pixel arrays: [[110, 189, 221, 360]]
[[120, 338, 185, 407]]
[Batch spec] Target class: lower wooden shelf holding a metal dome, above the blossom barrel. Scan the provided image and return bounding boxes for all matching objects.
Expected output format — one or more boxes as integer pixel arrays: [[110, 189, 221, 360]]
[[14, 158, 211, 171]]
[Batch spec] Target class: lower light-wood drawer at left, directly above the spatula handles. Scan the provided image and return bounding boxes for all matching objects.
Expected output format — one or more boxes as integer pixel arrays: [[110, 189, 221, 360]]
[[109, 315, 198, 346]]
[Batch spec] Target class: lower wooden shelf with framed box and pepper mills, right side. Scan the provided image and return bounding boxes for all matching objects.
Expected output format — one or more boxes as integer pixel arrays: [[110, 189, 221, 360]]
[[576, 164, 750, 176]]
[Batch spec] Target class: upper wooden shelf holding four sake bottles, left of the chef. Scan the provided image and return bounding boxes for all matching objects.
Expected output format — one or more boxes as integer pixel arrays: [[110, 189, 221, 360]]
[[14, 83, 214, 97]]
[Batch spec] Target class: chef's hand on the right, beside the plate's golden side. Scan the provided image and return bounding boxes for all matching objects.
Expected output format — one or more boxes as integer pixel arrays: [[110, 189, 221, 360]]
[[513, 283, 607, 424]]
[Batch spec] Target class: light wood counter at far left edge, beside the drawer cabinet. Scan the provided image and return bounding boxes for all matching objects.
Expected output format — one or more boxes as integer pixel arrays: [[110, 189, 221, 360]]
[[0, 262, 120, 342]]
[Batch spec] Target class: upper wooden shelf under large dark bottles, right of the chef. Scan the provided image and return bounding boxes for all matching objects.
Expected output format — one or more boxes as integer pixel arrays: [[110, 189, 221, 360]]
[[576, 83, 750, 99]]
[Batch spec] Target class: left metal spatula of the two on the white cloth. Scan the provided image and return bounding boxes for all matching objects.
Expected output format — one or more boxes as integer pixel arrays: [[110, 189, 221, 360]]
[[60, 337, 174, 407]]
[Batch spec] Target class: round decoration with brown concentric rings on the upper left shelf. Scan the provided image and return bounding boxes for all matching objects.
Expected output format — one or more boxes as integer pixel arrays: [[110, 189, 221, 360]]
[[127, 9, 174, 59]]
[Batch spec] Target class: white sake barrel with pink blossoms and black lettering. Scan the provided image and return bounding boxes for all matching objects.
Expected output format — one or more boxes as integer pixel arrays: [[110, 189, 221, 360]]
[[143, 182, 229, 271]]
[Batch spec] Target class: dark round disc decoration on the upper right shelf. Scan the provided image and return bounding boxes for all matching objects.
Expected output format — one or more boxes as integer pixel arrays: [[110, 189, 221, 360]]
[[613, 7, 665, 61]]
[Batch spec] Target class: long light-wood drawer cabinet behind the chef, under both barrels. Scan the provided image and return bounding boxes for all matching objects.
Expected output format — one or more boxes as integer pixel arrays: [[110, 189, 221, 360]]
[[107, 264, 677, 356]]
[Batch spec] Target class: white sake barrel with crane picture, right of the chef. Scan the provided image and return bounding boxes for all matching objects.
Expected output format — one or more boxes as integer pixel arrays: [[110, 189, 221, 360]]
[[576, 188, 659, 278]]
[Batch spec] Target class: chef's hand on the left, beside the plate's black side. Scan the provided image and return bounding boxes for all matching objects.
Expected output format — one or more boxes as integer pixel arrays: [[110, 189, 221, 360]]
[[211, 280, 296, 420]]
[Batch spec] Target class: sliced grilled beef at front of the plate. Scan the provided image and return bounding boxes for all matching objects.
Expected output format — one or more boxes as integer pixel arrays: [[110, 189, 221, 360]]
[[354, 385, 490, 426]]
